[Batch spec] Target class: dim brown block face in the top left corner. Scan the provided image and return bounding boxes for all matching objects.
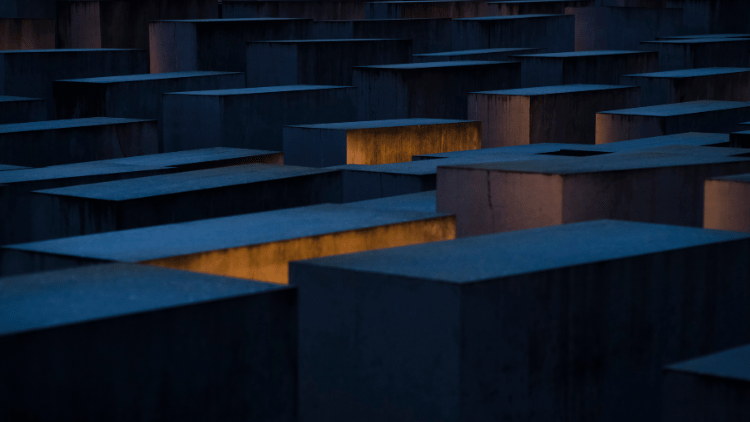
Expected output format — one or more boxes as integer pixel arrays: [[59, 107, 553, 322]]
[[0, 18, 55, 50]]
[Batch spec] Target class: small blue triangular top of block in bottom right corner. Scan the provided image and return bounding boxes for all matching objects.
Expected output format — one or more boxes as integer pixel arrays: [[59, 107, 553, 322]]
[[667, 345, 750, 382]]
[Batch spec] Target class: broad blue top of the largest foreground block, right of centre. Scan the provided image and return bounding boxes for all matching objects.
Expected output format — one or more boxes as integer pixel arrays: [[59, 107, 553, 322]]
[[292, 220, 750, 283]]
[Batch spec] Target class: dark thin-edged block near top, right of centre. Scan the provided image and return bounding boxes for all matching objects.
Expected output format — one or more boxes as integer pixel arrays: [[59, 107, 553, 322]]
[[452, 15, 575, 53]]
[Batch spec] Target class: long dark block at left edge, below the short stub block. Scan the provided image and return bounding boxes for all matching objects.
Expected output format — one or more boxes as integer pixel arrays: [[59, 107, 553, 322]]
[[0, 117, 158, 167]]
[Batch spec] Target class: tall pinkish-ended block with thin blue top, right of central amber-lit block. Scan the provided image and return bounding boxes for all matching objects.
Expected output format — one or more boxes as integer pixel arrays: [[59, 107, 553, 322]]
[[470, 85, 641, 148]]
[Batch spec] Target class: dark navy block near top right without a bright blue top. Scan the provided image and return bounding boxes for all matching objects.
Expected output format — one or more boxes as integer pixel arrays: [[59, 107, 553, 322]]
[[565, 7, 683, 51]]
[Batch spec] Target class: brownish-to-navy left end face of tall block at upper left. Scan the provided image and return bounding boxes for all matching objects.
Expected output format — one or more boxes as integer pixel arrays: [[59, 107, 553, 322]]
[[148, 21, 198, 73]]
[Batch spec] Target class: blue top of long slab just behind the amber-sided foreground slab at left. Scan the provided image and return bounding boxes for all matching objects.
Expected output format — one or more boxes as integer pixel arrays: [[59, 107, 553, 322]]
[[32, 164, 332, 201]]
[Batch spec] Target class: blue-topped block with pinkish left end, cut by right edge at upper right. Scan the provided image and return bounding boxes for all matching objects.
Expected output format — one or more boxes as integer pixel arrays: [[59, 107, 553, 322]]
[[596, 100, 750, 144]]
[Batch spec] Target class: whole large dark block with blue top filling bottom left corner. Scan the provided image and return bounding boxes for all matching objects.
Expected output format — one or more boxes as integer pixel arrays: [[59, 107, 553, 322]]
[[0, 264, 297, 422]]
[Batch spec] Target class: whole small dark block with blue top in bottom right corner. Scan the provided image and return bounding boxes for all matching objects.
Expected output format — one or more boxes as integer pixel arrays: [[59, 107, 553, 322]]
[[661, 345, 750, 422]]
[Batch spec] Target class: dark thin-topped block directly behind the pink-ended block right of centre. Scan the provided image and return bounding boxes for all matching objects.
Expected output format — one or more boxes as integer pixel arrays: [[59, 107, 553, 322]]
[[514, 50, 659, 88]]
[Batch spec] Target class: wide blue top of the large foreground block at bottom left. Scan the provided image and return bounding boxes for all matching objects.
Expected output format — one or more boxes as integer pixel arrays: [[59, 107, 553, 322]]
[[0, 264, 286, 336]]
